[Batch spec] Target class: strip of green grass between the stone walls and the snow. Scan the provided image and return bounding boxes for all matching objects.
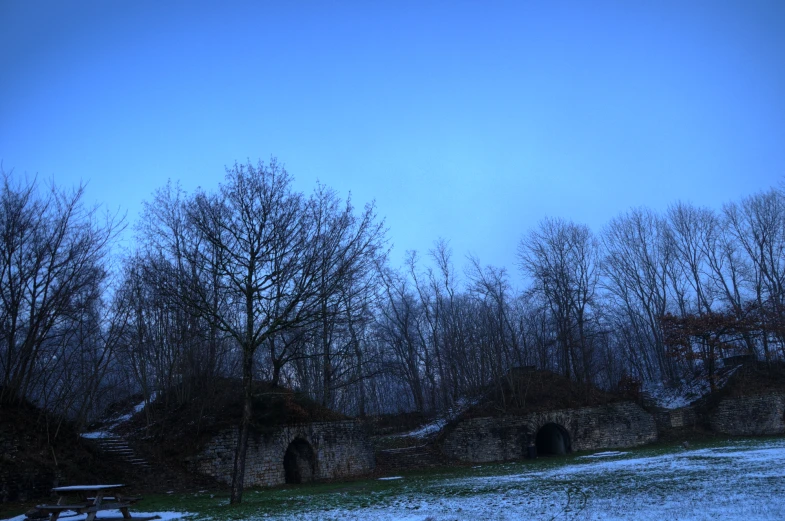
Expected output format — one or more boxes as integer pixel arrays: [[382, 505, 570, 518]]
[[130, 440, 761, 520]]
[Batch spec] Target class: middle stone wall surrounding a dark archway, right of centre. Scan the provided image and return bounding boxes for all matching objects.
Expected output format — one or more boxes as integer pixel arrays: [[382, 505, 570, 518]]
[[442, 402, 657, 462]]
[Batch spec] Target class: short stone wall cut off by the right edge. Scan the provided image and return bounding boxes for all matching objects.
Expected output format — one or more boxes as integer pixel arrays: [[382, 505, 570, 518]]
[[709, 393, 785, 436]]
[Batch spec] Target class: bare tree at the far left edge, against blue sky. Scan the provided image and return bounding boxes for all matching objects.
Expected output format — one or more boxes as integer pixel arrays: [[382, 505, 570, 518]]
[[0, 172, 120, 402]]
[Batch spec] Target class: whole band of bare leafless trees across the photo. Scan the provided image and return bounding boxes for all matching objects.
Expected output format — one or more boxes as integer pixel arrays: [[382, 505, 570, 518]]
[[0, 161, 785, 423]]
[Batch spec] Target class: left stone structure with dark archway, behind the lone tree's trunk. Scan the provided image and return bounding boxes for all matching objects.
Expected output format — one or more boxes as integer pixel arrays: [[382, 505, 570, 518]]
[[190, 420, 374, 487]]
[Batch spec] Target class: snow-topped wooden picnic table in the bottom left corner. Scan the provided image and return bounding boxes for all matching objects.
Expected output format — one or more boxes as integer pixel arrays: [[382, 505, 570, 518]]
[[36, 485, 159, 521]]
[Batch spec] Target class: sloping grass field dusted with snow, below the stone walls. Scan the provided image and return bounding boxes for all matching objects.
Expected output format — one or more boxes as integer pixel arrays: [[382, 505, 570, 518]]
[[6, 439, 785, 521]]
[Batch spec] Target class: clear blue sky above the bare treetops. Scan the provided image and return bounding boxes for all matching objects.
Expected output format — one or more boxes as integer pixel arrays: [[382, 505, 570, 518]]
[[0, 0, 785, 272]]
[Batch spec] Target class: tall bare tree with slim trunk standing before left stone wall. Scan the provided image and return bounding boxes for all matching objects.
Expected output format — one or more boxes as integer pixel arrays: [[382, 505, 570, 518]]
[[145, 160, 384, 503]]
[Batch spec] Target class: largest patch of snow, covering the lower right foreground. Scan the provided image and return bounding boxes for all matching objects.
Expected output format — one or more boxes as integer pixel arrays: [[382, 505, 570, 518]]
[[264, 440, 785, 521]]
